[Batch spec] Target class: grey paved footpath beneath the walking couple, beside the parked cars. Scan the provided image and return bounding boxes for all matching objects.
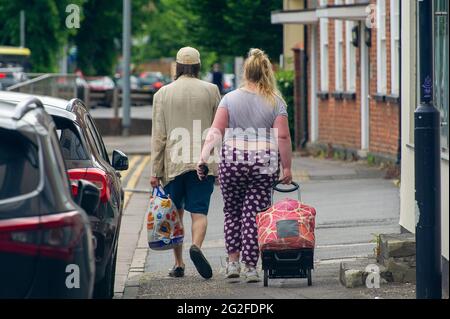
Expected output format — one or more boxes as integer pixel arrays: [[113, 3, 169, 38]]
[[105, 136, 415, 299]]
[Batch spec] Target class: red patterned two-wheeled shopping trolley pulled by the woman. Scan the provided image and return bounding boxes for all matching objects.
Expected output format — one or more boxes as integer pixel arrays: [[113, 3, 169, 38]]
[[256, 182, 316, 287]]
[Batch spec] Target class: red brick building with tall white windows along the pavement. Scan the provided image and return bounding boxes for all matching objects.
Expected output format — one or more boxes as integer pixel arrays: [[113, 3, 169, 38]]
[[272, 0, 400, 161]]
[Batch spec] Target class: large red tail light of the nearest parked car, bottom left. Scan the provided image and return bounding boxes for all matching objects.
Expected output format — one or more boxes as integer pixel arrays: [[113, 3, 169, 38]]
[[0, 211, 84, 261]]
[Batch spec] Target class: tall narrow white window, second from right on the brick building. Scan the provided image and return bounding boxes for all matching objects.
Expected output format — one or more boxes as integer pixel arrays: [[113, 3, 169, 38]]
[[377, 0, 387, 94]]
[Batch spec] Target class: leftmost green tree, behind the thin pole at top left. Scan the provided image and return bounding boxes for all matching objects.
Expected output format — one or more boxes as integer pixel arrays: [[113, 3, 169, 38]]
[[0, 0, 86, 72]]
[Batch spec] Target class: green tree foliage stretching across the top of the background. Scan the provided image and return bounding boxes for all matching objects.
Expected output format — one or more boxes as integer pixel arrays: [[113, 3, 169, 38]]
[[0, 0, 283, 75]]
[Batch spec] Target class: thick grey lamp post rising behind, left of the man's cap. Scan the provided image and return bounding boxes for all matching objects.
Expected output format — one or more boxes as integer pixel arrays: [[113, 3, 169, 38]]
[[122, 0, 131, 136]]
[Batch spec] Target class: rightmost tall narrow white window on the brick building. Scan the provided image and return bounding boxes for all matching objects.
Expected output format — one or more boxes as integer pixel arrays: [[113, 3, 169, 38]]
[[390, 0, 401, 96]]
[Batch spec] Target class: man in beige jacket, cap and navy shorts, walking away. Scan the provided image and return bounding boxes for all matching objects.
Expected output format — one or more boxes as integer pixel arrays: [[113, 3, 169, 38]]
[[150, 47, 221, 279]]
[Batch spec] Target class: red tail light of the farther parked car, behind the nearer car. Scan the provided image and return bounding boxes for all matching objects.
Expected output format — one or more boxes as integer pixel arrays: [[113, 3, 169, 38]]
[[67, 168, 111, 203]]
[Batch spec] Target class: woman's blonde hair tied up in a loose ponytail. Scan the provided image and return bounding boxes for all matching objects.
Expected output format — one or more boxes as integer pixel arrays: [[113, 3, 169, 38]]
[[242, 49, 284, 106]]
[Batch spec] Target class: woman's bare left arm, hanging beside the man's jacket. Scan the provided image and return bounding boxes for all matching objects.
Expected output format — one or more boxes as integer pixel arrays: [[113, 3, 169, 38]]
[[200, 107, 228, 163]]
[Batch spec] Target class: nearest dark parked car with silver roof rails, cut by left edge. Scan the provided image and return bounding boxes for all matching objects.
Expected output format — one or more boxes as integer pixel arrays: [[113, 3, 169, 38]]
[[0, 96, 100, 299]]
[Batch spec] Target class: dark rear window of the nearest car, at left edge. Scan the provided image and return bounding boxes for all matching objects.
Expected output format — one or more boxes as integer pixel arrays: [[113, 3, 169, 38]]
[[0, 128, 41, 201]]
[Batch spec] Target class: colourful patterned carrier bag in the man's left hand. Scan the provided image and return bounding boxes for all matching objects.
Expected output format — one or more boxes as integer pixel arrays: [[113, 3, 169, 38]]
[[147, 187, 184, 250]]
